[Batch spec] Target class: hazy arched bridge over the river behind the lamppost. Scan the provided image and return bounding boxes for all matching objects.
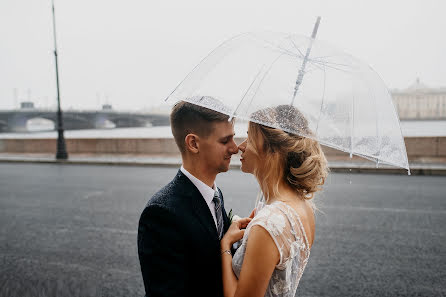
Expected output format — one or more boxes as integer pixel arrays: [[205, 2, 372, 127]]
[[0, 108, 169, 132]]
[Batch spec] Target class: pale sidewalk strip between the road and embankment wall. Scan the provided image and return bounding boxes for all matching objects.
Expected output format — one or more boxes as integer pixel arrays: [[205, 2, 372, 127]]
[[0, 153, 446, 175]]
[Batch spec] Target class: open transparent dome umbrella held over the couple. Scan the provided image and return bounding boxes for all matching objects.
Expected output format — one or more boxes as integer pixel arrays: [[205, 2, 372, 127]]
[[166, 19, 410, 174]]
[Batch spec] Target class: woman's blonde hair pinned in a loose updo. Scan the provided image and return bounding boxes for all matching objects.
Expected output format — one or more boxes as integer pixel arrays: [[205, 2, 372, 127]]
[[248, 105, 328, 201]]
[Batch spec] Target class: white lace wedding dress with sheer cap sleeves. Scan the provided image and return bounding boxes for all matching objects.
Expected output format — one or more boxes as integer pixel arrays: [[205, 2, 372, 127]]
[[232, 201, 310, 297]]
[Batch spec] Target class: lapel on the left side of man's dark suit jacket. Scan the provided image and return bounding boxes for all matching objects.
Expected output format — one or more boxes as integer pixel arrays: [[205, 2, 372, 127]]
[[177, 170, 218, 240]]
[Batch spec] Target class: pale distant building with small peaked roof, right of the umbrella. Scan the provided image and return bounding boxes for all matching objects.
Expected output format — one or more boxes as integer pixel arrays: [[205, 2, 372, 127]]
[[391, 78, 446, 120]]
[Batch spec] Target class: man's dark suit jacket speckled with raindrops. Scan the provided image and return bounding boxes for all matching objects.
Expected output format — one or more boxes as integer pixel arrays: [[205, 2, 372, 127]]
[[138, 170, 229, 297]]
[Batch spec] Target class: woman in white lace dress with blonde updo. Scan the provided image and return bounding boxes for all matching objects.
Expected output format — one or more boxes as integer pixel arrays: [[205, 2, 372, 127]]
[[220, 105, 328, 297]]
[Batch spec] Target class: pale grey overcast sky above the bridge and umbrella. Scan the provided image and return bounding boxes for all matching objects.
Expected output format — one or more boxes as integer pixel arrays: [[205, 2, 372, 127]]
[[0, 0, 446, 110]]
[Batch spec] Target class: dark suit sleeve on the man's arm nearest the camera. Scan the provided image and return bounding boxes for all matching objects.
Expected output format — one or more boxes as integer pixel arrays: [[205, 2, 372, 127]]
[[138, 205, 188, 297]]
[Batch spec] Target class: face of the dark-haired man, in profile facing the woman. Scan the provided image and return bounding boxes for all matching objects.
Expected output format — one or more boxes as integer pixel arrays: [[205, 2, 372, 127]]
[[200, 121, 238, 173]]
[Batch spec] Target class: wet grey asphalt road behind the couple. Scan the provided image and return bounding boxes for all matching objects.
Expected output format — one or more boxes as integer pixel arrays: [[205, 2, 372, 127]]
[[0, 163, 446, 297]]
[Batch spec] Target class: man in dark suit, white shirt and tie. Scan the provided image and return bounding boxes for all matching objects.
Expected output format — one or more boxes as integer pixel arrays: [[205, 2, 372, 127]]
[[138, 98, 238, 297]]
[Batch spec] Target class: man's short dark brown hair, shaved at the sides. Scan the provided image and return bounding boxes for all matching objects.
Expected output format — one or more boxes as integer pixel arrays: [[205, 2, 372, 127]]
[[170, 101, 229, 154]]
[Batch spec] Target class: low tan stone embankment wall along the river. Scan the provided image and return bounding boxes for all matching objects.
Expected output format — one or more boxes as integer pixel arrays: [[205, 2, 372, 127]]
[[0, 137, 446, 160]]
